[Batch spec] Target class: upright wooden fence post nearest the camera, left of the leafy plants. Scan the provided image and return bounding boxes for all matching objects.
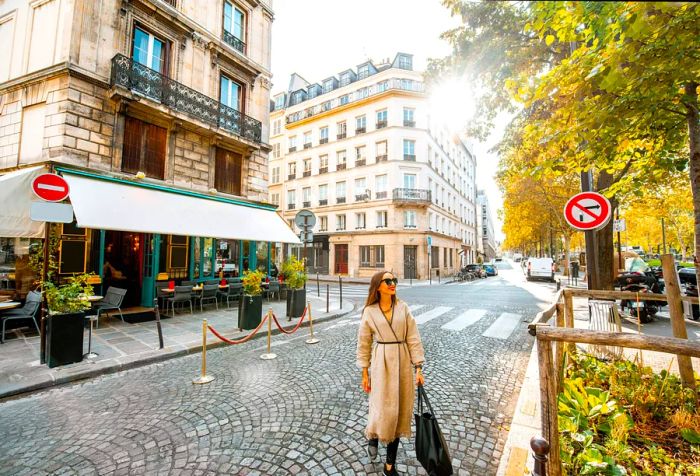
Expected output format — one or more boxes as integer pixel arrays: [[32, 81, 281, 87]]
[[537, 334, 561, 476]]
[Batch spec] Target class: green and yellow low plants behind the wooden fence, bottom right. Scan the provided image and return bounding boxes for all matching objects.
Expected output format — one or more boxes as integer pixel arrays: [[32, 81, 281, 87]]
[[558, 355, 700, 476]]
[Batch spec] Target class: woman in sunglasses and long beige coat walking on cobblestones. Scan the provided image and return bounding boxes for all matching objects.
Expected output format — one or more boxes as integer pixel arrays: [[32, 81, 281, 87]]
[[357, 271, 424, 476]]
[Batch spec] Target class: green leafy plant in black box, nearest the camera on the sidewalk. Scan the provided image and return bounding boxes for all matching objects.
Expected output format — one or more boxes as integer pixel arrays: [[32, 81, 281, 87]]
[[44, 273, 94, 367]]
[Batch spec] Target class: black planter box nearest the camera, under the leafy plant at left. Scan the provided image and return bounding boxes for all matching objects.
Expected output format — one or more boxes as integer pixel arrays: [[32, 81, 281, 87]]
[[46, 312, 85, 367]]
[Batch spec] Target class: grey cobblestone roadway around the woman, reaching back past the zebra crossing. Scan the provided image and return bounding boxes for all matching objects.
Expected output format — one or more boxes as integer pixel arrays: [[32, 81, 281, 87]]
[[0, 266, 552, 475]]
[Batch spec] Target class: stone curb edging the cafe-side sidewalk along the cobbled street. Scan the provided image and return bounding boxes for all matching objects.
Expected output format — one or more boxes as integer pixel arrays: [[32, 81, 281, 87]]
[[0, 301, 355, 402]]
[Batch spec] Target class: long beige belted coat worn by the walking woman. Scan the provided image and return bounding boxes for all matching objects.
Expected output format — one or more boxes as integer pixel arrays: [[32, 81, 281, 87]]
[[357, 300, 424, 443]]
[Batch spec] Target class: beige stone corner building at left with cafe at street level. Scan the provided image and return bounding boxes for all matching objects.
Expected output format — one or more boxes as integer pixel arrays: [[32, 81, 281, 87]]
[[0, 0, 291, 304]]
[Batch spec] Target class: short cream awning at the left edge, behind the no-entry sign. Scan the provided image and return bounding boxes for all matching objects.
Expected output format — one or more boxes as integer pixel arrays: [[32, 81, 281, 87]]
[[0, 166, 46, 238]]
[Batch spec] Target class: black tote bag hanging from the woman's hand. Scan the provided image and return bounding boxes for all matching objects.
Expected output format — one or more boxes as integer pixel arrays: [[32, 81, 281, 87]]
[[413, 386, 454, 476]]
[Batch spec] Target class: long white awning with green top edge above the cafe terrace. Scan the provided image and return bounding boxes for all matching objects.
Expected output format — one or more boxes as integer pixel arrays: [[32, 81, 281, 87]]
[[60, 168, 299, 243]]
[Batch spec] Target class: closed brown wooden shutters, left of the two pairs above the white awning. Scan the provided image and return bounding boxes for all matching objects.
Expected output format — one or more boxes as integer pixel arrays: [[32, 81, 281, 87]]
[[122, 116, 167, 180]]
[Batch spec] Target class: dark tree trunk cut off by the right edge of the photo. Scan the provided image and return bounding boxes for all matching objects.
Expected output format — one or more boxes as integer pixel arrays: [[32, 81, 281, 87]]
[[685, 81, 700, 283]]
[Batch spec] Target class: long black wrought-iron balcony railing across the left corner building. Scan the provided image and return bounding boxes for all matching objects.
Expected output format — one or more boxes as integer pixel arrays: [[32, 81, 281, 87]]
[[110, 54, 262, 143]]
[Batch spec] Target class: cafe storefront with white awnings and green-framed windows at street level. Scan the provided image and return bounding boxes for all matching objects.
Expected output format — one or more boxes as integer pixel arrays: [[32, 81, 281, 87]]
[[0, 166, 298, 307]]
